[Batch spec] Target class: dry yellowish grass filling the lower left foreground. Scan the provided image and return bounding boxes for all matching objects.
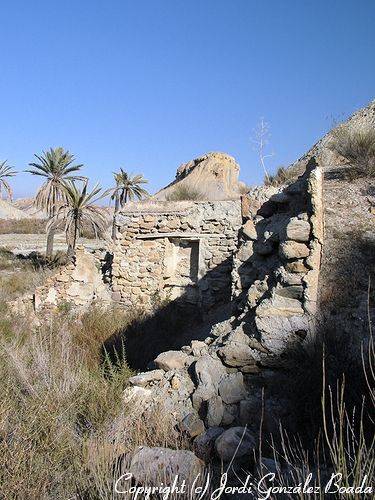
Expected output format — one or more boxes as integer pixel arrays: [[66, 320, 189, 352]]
[[0, 308, 187, 499]]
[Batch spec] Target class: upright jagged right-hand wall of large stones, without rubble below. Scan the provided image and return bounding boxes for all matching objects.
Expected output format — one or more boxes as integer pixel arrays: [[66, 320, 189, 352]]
[[233, 159, 323, 354]]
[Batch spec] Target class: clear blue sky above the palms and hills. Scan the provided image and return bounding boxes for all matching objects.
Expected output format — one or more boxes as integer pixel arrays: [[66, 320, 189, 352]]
[[0, 0, 375, 197]]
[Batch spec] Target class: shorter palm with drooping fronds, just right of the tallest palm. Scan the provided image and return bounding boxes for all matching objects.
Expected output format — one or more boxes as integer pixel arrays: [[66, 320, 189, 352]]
[[47, 180, 107, 256]]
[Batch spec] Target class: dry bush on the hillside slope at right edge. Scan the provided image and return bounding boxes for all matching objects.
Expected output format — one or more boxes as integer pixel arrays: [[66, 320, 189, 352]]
[[328, 124, 375, 178]]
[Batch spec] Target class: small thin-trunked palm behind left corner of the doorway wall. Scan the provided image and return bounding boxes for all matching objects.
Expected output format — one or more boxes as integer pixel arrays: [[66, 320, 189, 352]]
[[109, 168, 149, 239]]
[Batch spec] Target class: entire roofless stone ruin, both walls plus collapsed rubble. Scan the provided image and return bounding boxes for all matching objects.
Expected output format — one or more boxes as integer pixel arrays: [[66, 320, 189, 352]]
[[8, 151, 323, 459]]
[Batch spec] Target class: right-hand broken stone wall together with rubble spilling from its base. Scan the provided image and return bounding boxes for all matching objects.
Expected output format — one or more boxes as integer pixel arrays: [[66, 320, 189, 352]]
[[124, 160, 323, 460]]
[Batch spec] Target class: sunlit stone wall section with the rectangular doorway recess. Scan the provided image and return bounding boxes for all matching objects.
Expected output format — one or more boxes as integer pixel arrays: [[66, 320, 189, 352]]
[[112, 199, 242, 310]]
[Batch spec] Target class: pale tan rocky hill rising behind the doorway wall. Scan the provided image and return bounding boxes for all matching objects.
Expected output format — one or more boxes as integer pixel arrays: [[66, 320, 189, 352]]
[[154, 152, 243, 200]]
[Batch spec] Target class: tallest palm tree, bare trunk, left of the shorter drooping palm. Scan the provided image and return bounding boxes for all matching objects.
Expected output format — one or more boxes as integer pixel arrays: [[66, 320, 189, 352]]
[[26, 148, 84, 259]]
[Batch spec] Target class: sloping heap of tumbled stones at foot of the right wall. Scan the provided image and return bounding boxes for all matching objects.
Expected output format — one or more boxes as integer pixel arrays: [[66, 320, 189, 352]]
[[124, 322, 287, 461]]
